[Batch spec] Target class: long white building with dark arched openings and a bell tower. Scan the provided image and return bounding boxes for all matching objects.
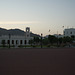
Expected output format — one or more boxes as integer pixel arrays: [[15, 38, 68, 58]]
[[0, 27, 33, 46]]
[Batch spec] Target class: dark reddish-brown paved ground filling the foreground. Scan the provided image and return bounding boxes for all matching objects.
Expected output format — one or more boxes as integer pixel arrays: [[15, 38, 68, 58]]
[[0, 48, 75, 75]]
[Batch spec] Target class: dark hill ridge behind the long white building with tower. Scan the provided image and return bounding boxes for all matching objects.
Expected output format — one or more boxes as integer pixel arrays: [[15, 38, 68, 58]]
[[0, 28, 40, 37]]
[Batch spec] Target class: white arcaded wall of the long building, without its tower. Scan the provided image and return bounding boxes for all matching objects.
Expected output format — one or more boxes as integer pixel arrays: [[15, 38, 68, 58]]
[[0, 35, 32, 45]]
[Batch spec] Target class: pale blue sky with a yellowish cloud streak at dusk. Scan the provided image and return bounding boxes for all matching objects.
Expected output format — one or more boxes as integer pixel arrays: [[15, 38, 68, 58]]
[[0, 0, 75, 36]]
